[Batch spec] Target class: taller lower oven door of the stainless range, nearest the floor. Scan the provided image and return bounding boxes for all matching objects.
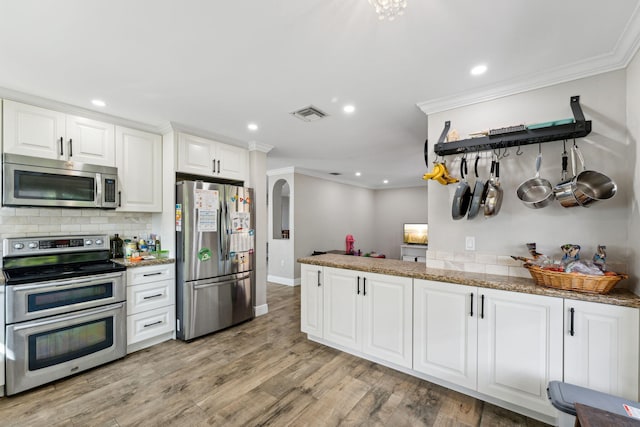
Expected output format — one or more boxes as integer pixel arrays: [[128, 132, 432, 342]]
[[6, 302, 127, 395]]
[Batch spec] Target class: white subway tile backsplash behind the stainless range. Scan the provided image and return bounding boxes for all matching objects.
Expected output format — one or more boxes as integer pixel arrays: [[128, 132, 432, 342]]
[[0, 207, 153, 264]]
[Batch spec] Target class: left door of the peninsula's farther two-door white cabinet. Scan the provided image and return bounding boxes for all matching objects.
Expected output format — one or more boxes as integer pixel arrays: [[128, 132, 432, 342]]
[[323, 267, 365, 350]]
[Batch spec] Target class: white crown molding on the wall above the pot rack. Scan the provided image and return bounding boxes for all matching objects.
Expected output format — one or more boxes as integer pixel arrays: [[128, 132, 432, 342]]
[[417, 4, 640, 115]]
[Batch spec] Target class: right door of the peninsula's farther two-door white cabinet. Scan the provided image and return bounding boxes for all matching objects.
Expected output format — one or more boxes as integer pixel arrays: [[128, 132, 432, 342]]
[[362, 273, 413, 368]]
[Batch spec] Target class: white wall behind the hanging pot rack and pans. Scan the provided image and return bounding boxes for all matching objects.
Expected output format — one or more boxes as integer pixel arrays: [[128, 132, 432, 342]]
[[428, 70, 638, 278]]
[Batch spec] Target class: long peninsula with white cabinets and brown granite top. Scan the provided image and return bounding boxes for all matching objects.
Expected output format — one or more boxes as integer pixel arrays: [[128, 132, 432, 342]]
[[298, 254, 640, 423]]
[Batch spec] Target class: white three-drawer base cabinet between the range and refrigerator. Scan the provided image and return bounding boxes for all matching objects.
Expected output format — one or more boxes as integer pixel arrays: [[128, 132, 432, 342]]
[[127, 264, 176, 353]]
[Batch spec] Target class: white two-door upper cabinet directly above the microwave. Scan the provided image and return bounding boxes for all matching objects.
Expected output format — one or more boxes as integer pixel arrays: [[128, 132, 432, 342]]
[[3, 100, 115, 166]]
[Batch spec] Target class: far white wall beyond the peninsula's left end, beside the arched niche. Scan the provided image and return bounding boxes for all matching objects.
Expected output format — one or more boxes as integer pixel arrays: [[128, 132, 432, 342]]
[[291, 173, 378, 278]]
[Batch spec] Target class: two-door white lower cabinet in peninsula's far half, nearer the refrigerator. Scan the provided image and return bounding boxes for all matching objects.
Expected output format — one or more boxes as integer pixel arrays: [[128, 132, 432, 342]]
[[322, 267, 412, 368]]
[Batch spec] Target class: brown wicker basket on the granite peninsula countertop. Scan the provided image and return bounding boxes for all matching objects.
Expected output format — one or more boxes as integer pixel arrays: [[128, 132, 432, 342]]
[[524, 264, 629, 294]]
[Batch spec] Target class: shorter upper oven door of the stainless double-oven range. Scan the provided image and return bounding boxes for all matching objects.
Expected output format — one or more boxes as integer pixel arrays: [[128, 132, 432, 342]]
[[5, 272, 126, 324]]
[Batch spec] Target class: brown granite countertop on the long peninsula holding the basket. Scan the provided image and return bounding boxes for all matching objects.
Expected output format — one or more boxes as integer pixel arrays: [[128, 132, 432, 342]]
[[298, 254, 640, 308]]
